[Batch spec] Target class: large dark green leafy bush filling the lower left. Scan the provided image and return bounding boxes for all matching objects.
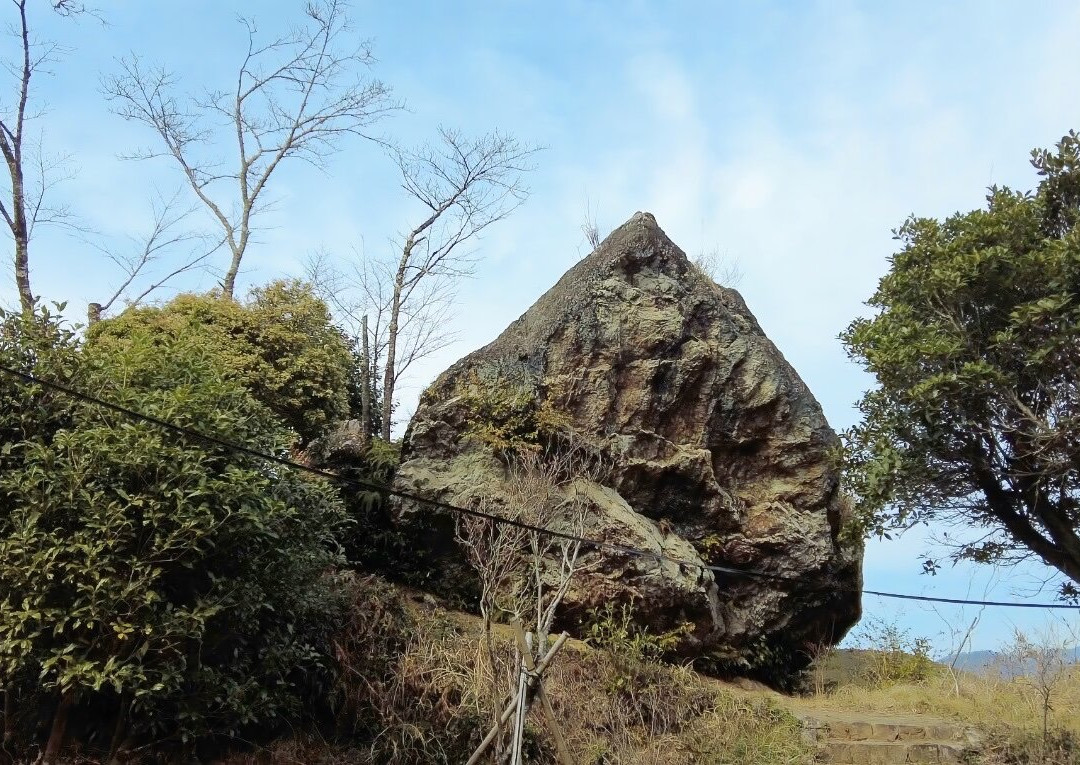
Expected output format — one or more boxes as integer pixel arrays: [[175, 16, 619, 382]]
[[0, 316, 345, 763]]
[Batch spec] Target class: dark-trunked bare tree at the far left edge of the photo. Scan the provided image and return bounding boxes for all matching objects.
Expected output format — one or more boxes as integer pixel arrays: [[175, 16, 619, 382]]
[[0, 0, 86, 311]]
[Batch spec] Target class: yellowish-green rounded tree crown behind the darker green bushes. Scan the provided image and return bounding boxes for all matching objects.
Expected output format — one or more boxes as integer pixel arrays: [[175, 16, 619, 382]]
[[90, 281, 354, 441]]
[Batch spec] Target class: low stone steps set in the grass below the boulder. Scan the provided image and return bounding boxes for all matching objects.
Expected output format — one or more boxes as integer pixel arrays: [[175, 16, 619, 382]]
[[799, 710, 981, 765]]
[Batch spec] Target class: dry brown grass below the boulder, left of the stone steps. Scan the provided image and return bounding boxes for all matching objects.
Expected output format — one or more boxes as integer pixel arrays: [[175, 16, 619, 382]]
[[227, 579, 813, 765]]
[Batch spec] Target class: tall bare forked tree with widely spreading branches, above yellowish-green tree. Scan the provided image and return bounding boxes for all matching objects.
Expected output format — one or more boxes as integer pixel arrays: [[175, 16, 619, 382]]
[[104, 0, 399, 297]]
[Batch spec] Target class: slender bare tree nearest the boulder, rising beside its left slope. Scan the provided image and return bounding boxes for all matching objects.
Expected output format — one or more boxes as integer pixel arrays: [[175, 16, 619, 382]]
[[379, 129, 540, 440]]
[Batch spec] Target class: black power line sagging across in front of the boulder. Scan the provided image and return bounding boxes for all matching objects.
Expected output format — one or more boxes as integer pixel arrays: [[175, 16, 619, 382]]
[[0, 365, 1080, 610]]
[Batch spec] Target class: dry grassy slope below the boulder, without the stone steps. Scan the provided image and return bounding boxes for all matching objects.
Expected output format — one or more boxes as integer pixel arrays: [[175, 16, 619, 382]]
[[219, 585, 1080, 765]]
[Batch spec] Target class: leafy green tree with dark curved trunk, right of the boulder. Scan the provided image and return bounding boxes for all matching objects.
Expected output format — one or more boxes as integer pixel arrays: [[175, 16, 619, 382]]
[[841, 132, 1080, 594]]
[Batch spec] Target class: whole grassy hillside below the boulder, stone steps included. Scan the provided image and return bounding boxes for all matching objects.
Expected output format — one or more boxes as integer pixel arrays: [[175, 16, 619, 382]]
[[208, 580, 1080, 765]]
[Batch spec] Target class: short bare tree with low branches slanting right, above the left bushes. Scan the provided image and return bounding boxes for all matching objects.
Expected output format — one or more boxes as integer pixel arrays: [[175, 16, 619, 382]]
[[86, 193, 221, 324]]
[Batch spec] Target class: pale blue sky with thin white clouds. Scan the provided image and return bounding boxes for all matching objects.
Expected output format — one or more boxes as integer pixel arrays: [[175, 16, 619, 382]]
[[6, 0, 1080, 647]]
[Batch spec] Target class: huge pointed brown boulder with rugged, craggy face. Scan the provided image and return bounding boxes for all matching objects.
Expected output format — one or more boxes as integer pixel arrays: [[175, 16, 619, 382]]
[[396, 213, 862, 679]]
